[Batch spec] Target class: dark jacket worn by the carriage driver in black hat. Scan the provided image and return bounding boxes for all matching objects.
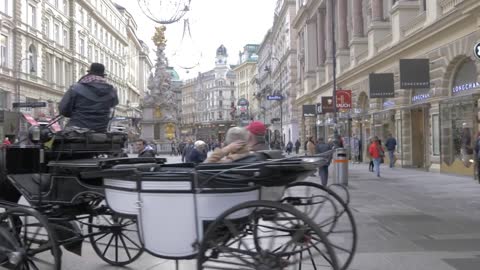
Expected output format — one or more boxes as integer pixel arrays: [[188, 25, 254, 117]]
[[59, 75, 118, 132]]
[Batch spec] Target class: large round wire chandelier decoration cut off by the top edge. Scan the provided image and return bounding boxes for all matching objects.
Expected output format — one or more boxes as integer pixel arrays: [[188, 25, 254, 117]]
[[138, 0, 191, 24]]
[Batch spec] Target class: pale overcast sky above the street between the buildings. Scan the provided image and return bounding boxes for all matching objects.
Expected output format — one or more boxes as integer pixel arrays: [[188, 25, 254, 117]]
[[114, 0, 277, 80]]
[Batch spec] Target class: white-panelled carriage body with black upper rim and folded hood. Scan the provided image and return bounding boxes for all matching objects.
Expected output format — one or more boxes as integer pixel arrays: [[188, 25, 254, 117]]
[[104, 160, 317, 259]]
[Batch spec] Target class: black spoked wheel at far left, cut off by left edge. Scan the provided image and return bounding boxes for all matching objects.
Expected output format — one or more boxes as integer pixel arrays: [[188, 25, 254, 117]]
[[0, 207, 62, 270]]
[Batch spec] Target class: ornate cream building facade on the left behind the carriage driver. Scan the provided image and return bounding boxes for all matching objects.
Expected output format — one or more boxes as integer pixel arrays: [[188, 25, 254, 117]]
[[0, 0, 149, 139]]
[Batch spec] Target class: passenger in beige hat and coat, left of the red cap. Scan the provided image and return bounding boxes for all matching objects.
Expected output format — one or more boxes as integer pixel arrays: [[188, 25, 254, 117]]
[[205, 127, 250, 163]]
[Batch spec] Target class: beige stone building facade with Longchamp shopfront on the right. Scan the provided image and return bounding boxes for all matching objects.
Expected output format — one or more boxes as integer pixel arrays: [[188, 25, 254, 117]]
[[294, 0, 480, 176]]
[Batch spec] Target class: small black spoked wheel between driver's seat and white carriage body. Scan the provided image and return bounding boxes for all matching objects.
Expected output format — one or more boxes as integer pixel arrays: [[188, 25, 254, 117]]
[[88, 213, 144, 266]]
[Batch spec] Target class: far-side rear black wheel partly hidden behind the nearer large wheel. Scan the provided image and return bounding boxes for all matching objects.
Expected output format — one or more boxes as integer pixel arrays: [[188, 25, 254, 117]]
[[282, 182, 358, 270]]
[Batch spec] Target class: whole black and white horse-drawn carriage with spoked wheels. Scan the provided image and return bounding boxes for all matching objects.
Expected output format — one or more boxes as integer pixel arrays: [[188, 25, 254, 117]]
[[0, 117, 356, 269]]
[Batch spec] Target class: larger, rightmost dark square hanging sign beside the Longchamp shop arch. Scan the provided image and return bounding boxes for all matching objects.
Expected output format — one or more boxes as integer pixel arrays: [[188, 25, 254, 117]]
[[400, 59, 430, 89]]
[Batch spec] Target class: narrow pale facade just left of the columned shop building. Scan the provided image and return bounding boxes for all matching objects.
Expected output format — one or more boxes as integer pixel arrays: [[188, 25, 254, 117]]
[[257, 0, 300, 145]]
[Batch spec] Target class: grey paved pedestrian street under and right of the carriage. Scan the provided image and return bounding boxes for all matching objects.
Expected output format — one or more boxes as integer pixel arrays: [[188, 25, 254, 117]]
[[30, 156, 480, 270]]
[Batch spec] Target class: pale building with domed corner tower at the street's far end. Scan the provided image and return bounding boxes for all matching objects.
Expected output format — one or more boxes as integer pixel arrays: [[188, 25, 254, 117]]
[[181, 45, 236, 141]]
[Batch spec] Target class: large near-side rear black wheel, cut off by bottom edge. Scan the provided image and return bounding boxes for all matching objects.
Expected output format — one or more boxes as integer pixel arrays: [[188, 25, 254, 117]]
[[197, 201, 339, 270]]
